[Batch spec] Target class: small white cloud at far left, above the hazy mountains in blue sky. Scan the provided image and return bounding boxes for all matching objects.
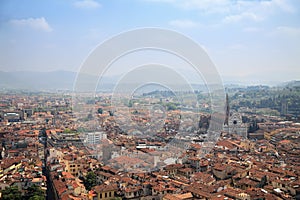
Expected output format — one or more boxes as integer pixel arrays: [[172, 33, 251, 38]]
[[10, 17, 53, 32]]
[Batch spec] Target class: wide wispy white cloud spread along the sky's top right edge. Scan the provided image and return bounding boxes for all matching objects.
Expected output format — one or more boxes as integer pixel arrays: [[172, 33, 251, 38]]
[[142, 0, 296, 22]]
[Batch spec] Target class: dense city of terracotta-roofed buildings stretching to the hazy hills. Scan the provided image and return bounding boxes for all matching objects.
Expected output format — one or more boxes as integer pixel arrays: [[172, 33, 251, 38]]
[[0, 82, 300, 200]]
